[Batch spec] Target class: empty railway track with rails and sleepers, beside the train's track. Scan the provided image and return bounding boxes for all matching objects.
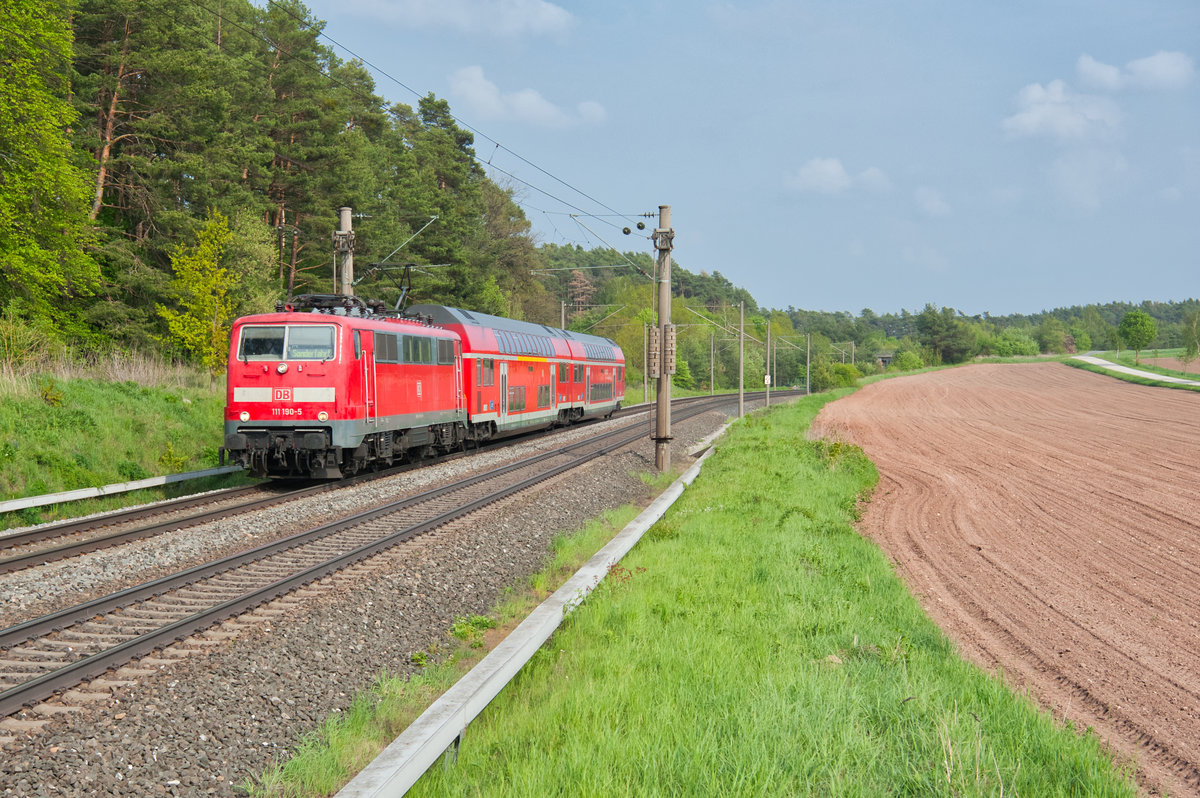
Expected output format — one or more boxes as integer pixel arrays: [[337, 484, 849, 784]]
[[0, 396, 758, 716]]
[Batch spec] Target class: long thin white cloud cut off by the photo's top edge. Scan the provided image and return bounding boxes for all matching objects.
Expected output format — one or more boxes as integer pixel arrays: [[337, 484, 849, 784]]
[[346, 0, 576, 36]]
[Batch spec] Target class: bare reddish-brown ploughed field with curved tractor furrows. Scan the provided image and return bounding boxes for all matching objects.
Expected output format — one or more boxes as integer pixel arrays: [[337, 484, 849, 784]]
[[814, 364, 1200, 796]]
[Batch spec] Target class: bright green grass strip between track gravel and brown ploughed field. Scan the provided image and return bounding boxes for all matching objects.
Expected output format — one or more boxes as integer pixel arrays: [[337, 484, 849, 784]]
[[250, 391, 1136, 796]]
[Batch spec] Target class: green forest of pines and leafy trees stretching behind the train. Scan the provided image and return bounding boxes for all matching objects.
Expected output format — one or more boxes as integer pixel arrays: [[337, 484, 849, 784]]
[[0, 0, 1198, 388]]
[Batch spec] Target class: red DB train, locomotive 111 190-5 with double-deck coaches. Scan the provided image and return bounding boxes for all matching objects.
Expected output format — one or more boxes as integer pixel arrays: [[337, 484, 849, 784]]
[[222, 295, 625, 479]]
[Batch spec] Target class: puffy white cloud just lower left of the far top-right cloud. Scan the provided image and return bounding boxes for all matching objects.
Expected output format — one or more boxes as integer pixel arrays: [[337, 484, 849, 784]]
[[1003, 80, 1121, 142]]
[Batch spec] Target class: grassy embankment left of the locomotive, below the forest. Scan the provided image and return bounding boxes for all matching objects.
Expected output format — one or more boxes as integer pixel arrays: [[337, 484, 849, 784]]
[[0, 356, 245, 529]]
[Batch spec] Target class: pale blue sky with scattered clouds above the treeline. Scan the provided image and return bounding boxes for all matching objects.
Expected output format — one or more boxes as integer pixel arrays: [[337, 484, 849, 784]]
[[295, 0, 1200, 314]]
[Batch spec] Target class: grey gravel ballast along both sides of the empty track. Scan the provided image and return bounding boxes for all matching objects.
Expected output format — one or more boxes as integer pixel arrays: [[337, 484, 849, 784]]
[[0, 398, 737, 797]]
